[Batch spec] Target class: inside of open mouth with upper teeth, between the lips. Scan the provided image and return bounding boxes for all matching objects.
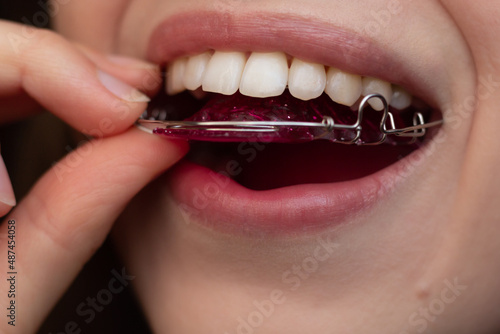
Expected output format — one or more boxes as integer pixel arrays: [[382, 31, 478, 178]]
[[143, 51, 440, 190]]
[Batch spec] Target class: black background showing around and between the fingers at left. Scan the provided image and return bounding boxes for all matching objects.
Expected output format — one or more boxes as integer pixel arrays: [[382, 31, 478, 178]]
[[0, 0, 151, 334]]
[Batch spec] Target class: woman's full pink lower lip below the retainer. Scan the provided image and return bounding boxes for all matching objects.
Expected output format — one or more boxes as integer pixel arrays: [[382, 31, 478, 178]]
[[169, 148, 412, 235]]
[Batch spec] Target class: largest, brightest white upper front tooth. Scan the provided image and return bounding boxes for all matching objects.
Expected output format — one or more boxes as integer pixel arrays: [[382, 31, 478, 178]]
[[240, 52, 288, 97]]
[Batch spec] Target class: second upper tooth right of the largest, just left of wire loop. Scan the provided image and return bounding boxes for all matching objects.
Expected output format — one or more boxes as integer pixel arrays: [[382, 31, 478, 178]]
[[325, 67, 363, 107]]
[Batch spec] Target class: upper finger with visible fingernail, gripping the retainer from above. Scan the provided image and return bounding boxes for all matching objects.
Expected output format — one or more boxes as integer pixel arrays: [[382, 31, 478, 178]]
[[0, 21, 160, 136]]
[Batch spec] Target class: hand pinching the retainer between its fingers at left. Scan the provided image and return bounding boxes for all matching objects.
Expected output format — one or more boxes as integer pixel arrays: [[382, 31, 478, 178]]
[[0, 21, 187, 333]]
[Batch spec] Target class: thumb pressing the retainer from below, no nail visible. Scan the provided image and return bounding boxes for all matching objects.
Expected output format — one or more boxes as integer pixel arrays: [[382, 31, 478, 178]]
[[0, 128, 187, 333]]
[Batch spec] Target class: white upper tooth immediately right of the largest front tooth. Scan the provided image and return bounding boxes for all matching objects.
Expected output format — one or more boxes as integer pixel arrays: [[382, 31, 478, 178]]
[[288, 58, 326, 101]]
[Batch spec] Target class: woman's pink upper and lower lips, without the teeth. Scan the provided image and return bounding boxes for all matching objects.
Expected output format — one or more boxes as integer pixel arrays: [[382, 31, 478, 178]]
[[148, 12, 438, 235]]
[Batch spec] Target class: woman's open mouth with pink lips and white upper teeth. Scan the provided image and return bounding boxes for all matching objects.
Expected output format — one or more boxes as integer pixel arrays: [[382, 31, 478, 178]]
[[146, 13, 446, 235]]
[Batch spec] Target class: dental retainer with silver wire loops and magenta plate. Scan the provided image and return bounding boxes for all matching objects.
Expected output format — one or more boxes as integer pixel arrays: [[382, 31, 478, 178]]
[[137, 94, 444, 145]]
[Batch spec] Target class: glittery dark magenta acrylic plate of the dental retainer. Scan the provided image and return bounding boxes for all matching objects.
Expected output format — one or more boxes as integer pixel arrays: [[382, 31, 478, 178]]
[[155, 91, 412, 144]]
